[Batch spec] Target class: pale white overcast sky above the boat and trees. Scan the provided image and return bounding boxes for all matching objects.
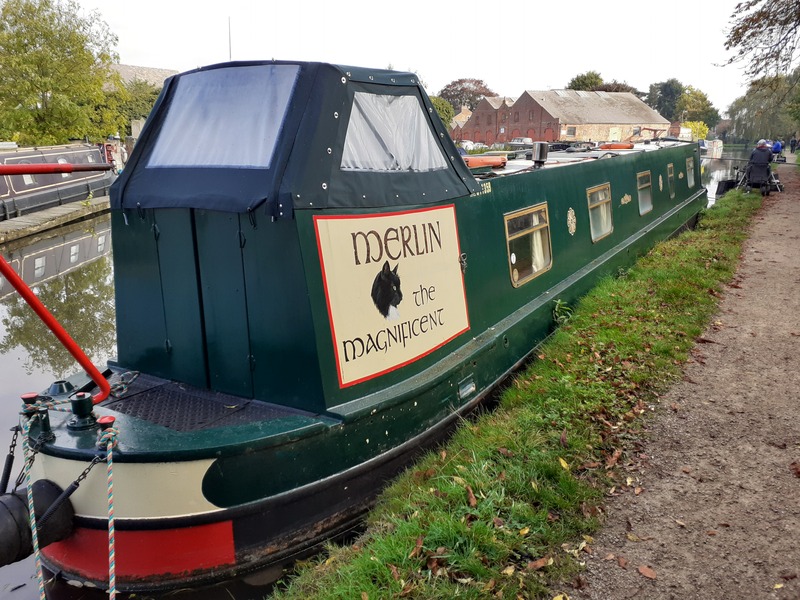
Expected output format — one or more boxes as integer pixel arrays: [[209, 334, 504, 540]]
[[79, 0, 746, 113]]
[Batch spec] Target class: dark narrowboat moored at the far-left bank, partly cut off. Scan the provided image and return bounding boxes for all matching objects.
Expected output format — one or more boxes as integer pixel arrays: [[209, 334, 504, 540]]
[[0, 144, 116, 221]]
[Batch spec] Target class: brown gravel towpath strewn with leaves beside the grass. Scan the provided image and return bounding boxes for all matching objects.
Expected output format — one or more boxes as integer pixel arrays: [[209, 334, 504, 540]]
[[568, 155, 800, 600]]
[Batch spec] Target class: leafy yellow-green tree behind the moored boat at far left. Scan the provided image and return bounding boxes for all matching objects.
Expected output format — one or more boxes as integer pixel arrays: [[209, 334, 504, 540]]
[[0, 0, 122, 144]]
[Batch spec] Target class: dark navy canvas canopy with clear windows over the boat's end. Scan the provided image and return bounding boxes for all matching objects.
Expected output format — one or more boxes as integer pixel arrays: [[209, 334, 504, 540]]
[[111, 61, 479, 217]]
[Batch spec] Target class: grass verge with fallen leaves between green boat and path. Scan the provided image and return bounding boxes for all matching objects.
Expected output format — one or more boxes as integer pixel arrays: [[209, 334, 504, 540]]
[[272, 191, 762, 600]]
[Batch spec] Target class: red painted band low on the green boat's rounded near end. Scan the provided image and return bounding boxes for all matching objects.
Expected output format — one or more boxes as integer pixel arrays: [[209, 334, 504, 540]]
[[42, 521, 235, 582]]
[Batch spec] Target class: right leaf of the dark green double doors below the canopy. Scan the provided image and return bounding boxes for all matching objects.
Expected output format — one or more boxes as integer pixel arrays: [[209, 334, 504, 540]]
[[194, 210, 253, 398]]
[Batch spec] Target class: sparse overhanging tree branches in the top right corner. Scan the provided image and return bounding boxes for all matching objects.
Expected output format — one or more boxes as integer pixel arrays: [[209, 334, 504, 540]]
[[725, 0, 800, 82]]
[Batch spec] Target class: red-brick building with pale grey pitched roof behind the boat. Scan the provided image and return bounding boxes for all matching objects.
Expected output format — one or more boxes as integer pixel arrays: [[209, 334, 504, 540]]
[[458, 90, 670, 145]]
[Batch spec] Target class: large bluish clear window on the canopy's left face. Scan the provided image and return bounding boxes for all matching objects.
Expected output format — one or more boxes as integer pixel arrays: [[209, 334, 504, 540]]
[[147, 65, 299, 169]]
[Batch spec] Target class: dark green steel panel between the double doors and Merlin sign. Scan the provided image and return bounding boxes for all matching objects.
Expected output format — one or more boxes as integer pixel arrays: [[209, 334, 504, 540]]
[[241, 211, 325, 412]]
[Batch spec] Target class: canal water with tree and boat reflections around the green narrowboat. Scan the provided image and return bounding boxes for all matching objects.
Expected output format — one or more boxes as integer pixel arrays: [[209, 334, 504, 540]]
[[0, 151, 746, 600]]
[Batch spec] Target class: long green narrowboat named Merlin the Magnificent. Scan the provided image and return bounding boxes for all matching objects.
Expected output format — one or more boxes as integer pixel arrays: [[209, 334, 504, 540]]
[[0, 61, 707, 592]]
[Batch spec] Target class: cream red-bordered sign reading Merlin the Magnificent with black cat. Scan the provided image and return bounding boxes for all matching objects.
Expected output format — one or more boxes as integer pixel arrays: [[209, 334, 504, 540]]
[[314, 205, 469, 387]]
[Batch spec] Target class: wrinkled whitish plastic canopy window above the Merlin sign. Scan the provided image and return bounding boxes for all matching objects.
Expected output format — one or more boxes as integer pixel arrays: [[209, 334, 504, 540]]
[[341, 92, 448, 172]]
